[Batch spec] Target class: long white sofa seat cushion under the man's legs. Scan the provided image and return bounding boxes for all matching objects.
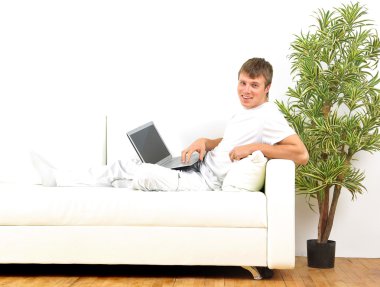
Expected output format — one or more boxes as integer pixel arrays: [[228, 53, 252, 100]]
[[0, 184, 267, 228]]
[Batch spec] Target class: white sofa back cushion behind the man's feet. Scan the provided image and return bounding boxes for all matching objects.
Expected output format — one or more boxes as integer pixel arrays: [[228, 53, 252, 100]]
[[0, 112, 106, 184]]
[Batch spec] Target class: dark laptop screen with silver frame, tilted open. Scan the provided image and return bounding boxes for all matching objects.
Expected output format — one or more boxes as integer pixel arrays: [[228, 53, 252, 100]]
[[128, 123, 170, 163]]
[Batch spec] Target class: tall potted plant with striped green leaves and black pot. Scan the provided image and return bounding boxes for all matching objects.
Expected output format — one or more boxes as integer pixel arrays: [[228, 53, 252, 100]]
[[277, 3, 380, 268]]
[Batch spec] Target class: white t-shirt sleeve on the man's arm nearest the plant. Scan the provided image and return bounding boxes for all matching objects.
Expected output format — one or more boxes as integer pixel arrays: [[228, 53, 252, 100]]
[[263, 108, 295, 145]]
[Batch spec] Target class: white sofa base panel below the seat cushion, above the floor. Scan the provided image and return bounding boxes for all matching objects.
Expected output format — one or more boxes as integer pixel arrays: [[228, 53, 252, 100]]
[[0, 226, 267, 266]]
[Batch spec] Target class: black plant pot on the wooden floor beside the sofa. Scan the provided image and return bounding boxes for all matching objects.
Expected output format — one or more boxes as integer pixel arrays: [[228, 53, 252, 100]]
[[307, 239, 335, 268]]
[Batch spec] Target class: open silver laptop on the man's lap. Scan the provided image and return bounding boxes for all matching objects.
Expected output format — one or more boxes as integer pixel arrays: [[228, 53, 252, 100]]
[[127, 122, 199, 169]]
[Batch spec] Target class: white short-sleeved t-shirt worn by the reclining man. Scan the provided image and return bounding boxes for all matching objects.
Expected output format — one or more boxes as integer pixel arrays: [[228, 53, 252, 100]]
[[200, 102, 295, 189]]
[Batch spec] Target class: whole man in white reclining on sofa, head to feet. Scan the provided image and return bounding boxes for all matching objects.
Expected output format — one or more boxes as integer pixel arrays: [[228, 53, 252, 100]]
[[33, 58, 309, 191]]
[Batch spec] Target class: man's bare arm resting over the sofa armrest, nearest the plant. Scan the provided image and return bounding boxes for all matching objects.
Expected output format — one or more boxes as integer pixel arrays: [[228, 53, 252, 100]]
[[230, 135, 309, 165]]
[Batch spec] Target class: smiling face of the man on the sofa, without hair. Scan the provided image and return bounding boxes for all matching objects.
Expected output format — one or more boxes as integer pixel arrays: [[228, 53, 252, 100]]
[[238, 72, 270, 109]]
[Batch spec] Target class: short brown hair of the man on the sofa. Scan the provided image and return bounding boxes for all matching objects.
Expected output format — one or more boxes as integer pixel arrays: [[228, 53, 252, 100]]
[[238, 58, 273, 87]]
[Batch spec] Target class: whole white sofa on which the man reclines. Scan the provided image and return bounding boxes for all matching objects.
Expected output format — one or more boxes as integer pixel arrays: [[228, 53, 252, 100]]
[[0, 116, 295, 278]]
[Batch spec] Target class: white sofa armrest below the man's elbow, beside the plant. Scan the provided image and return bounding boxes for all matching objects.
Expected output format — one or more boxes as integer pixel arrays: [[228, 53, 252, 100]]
[[265, 159, 295, 269]]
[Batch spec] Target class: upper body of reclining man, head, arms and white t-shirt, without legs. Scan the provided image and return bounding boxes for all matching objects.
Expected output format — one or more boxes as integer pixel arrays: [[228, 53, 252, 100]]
[[182, 58, 309, 190]]
